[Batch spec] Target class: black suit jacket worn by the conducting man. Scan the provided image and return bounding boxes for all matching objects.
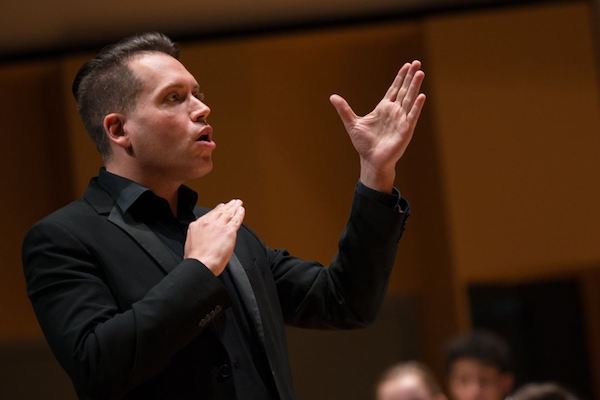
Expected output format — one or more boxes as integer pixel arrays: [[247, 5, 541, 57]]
[[23, 179, 408, 399]]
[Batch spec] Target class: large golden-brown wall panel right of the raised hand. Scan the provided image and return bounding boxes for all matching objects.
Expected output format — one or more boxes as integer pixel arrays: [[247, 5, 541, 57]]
[[425, 2, 600, 282]]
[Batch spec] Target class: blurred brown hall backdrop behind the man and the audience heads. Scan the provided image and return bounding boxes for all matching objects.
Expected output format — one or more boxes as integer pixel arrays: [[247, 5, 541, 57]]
[[0, 0, 600, 399]]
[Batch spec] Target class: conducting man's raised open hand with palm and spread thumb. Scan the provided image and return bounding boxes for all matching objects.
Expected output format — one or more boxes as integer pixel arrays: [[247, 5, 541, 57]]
[[329, 61, 425, 192]]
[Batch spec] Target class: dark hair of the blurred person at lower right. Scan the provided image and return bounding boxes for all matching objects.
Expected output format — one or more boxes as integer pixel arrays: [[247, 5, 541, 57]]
[[446, 330, 514, 373]]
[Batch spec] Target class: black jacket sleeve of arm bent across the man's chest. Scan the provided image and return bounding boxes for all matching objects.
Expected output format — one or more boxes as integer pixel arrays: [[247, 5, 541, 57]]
[[23, 221, 230, 399]]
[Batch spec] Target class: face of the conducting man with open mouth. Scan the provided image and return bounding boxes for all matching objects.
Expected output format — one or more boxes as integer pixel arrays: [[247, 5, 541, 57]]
[[123, 53, 216, 183]]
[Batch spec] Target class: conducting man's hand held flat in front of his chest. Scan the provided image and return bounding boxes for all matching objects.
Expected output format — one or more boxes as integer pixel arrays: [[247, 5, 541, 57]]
[[184, 200, 245, 276]]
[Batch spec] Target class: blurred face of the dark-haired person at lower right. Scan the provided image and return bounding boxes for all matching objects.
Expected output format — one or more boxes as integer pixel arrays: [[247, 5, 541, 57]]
[[448, 358, 513, 400]]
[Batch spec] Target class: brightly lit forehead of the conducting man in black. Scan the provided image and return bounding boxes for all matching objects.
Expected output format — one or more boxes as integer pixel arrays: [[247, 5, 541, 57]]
[[128, 52, 197, 89]]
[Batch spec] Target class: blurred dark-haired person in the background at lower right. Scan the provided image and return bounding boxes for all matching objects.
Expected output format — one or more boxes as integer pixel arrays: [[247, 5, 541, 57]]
[[446, 331, 514, 400]]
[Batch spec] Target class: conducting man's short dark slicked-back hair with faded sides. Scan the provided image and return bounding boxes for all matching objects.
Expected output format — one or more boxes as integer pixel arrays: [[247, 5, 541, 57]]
[[71, 32, 179, 160]]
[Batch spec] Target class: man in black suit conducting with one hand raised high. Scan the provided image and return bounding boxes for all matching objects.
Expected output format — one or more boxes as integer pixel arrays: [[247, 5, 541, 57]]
[[23, 33, 425, 399]]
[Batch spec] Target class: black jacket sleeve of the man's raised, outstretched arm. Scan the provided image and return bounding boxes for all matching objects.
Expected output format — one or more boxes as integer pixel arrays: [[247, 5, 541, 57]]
[[268, 183, 410, 329]]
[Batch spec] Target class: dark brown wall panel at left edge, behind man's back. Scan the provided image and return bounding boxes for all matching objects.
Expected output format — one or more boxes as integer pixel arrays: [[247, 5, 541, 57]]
[[0, 62, 72, 340]]
